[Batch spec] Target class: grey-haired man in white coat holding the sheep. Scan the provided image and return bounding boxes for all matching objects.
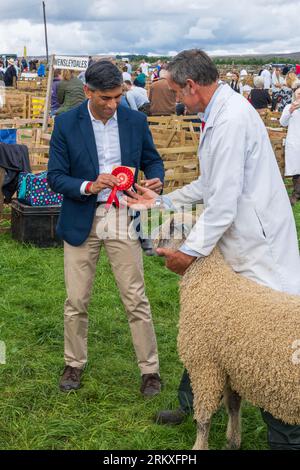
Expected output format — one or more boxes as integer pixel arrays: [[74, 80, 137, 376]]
[[127, 49, 300, 449]]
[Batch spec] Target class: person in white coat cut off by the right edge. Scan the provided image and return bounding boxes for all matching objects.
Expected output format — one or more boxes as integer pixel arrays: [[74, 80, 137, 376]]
[[280, 81, 300, 206]]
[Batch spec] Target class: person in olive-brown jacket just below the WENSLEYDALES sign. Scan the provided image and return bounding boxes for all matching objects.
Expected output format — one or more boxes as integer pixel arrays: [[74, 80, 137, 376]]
[[56, 70, 85, 114]]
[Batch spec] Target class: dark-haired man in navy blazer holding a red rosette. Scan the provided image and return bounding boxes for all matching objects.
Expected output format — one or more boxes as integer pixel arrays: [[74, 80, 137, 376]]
[[48, 61, 164, 396]]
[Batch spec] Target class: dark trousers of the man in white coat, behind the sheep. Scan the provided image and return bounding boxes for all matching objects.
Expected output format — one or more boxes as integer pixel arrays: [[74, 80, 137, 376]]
[[178, 369, 300, 450]]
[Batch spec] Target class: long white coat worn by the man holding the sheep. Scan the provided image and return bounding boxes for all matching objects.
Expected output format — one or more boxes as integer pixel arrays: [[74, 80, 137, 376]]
[[168, 85, 300, 294]]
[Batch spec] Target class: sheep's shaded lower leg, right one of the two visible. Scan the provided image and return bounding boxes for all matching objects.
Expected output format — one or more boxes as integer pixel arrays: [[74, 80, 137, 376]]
[[224, 385, 242, 449]]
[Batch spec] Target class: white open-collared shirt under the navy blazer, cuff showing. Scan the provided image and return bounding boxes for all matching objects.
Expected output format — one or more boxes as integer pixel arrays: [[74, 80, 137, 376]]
[[80, 102, 121, 201]]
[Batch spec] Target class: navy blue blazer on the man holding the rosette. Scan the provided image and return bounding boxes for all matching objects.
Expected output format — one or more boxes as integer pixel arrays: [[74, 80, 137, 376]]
[[48, 101, 164, 246]]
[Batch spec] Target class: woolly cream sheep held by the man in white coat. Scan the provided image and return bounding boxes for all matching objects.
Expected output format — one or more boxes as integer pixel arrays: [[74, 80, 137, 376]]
[[154, 214, 300, 450]]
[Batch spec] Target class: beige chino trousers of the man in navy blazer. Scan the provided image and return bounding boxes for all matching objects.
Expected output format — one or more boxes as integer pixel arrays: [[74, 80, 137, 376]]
[[64, 205, 159, 374]]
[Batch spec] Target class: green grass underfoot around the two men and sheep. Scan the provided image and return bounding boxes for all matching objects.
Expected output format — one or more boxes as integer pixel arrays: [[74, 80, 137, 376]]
[[0, 203, 300, 449]]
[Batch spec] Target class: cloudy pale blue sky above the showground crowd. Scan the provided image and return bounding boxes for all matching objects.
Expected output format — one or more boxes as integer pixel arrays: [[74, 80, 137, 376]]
[[0, 0, 300, 55]]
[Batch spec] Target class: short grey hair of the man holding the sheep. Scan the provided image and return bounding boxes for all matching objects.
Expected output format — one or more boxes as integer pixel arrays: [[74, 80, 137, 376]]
[[167, 49, 219, 88]]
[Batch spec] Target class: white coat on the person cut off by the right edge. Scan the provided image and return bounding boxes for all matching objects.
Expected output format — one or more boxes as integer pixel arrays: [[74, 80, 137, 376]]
[[280, 104, 300, 176]]
